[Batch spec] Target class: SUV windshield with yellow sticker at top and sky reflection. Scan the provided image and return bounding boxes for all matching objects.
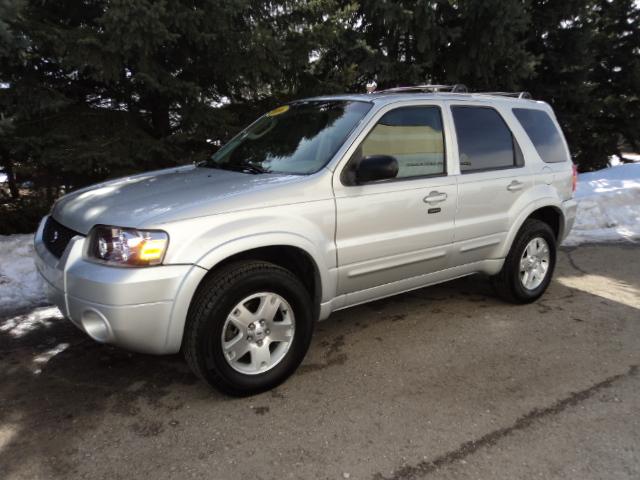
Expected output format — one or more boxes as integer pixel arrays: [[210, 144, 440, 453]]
[[203, 100, 371, 174]]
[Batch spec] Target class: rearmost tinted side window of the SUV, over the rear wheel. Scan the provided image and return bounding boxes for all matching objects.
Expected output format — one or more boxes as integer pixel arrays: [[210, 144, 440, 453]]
[[513, 108, 569, 163]]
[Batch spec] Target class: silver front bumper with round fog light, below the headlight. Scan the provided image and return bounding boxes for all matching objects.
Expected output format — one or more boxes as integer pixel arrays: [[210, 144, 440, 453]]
[[35, 217, 207, 354]]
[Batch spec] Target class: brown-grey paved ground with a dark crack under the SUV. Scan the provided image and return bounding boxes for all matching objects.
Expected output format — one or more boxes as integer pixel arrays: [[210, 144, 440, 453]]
[[0, 245, 640, 480]]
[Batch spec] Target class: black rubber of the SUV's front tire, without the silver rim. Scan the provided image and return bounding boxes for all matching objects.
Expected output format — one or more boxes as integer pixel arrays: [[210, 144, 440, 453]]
[[197, 266, 314, 395]]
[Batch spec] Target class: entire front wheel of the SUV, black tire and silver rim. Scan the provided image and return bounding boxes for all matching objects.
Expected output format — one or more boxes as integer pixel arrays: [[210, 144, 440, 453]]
[[183, 261, 314, 396]]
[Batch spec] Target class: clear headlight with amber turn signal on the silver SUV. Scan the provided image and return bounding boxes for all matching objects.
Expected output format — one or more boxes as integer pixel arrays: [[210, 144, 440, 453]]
[[87, 225, 169, 267]]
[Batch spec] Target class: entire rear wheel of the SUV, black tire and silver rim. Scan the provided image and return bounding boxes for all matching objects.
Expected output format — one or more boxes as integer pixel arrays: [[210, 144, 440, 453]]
[[492, 218, 557, 303]]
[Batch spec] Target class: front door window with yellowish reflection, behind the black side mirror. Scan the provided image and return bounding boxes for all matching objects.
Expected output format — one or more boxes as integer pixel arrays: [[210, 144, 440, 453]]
[[356, 107, 445, 178]]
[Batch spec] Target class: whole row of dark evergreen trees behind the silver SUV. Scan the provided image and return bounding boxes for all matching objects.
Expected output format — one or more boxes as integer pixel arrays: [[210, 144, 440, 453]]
[[0, 0, 640, 232]]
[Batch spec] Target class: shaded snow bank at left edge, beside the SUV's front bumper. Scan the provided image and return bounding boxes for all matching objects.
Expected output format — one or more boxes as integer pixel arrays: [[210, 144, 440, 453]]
[[0, 235, 46, 315]]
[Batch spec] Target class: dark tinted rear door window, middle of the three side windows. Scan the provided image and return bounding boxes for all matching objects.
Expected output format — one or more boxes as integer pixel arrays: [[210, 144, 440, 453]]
[[451, 107, 516, 173]]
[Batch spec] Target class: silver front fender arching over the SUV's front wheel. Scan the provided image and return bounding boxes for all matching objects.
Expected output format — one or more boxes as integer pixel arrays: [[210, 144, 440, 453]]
[[158, 201, 337, 350]]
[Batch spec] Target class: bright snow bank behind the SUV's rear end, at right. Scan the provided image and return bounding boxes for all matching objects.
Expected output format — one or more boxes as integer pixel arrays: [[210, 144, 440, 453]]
[[564, 163, 640, 245]]
